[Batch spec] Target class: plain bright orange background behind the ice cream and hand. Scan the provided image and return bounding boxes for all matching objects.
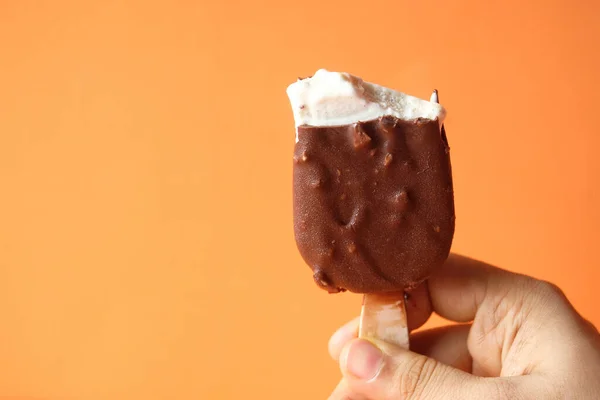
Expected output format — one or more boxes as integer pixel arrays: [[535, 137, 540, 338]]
[[0, 0, 600, 400]]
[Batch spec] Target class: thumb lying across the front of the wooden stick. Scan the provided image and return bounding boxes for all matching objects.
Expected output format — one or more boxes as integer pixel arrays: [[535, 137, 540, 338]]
[[340, 339, 500, 400]]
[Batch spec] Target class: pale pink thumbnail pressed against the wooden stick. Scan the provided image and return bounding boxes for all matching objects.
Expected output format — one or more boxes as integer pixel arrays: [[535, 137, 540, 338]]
[[341, 339, 383, 381]]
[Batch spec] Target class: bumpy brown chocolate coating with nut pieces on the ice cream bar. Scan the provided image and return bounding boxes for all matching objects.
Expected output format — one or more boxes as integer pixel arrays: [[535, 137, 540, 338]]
[[294, 117, 455, 293]]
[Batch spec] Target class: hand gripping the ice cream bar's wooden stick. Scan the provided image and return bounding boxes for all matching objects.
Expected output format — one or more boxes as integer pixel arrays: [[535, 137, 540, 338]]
[[329, 255, 600, 400]]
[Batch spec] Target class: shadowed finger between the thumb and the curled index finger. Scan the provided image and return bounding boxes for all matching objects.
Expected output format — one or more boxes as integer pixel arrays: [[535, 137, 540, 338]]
[[410, 325, 473, 373]]
